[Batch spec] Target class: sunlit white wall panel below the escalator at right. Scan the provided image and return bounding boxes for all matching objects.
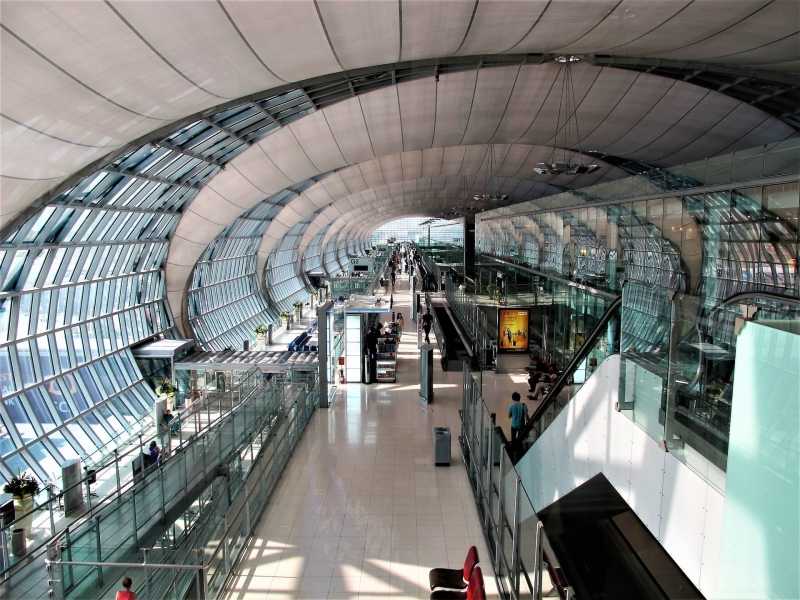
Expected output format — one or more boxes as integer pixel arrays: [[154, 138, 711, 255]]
[[517, 356, 736, 597]]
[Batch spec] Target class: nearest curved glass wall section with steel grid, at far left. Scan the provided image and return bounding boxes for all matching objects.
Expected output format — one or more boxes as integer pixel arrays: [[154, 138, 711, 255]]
[[0, 90, 326, 481]]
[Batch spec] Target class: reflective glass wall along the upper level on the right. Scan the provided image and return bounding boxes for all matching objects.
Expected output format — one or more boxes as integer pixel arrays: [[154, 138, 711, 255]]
[[476, 183, 800, 480]]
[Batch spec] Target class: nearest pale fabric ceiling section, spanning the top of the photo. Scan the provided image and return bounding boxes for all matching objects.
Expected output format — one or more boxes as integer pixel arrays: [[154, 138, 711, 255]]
[[0, 0, 800, 225]]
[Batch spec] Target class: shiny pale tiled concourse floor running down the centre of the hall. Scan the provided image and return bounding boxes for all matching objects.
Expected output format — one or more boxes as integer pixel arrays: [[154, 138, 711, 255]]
[[225, 276, 497, 600]]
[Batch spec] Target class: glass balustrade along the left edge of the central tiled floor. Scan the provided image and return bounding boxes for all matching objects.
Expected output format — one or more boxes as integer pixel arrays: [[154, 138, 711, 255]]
[[47, 372, 319, 600]]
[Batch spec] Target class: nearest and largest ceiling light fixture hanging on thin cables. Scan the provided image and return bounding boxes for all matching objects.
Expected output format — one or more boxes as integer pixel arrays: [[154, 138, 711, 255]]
[[533, 56, 600, 175]]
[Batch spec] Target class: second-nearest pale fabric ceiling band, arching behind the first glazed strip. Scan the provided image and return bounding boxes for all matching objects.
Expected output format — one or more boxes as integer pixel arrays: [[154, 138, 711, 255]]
[[167, 63, 795, 332]]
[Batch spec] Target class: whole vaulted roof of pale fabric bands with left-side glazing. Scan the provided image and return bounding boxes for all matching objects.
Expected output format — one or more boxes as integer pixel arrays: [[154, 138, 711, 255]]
[[0, 0, 800, 502]]
